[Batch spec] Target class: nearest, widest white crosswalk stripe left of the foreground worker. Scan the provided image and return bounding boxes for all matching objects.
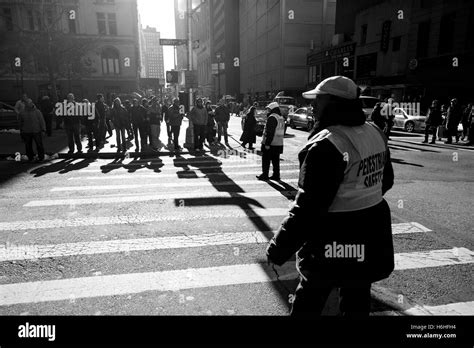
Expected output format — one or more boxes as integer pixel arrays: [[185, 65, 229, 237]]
[[0, 264, 296, 306]]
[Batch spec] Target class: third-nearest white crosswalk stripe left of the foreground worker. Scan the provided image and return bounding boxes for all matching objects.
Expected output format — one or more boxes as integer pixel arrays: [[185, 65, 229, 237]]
[[0, 208, 288, 231]]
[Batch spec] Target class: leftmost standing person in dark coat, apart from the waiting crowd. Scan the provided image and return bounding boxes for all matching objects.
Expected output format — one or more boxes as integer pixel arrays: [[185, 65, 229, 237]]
[[19, 98, 46, 162]]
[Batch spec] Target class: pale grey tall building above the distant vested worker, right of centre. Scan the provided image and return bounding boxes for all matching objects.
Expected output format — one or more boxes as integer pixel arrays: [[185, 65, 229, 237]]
[[239, 0, 336, 99]]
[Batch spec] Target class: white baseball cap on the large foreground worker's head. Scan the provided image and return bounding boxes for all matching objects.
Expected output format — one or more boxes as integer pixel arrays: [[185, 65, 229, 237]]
[[303, 76, 357, 99]]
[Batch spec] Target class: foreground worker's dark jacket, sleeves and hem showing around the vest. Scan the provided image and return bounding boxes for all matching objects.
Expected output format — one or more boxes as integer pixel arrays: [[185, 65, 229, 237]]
[[267, 99, 394, 285]]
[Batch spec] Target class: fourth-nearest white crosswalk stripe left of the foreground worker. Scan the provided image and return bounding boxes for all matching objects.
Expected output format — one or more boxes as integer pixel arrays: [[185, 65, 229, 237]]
[[23, 191, 295, 207]]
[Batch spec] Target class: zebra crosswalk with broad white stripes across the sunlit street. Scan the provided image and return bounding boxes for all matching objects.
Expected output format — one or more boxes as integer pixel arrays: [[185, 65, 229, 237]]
[[0, 155, 474, 315]]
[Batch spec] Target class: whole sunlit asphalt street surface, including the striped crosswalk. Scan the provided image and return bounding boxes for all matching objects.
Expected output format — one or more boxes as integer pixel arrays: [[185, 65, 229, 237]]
[[0, 118, 474, 315]]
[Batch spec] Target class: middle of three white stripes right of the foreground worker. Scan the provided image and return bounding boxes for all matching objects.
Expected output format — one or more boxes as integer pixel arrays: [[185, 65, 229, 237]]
[[395, 248, 474, 270]]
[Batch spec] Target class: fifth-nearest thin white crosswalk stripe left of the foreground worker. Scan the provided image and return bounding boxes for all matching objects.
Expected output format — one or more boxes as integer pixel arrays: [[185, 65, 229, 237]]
[[50, 179, 298, 192]]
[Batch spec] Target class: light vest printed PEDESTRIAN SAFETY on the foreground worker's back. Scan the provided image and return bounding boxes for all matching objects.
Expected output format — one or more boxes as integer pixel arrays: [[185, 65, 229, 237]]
[[308, 123, 388, 212]]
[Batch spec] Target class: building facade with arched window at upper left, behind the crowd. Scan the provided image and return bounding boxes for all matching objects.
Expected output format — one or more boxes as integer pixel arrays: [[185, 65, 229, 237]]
[[0, 0, 140, 101]]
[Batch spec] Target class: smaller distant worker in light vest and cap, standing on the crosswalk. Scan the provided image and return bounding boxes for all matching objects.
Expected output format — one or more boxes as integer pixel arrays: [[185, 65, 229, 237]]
[[257, 102, 285, 181]]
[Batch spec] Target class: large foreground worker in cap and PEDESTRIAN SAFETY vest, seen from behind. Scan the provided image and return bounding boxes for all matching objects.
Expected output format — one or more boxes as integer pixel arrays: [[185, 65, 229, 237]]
[[267, 76, 394, 316]]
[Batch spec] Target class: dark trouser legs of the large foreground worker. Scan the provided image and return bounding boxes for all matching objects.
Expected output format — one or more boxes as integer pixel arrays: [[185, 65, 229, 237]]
[[291, 279, 371, 316]]
